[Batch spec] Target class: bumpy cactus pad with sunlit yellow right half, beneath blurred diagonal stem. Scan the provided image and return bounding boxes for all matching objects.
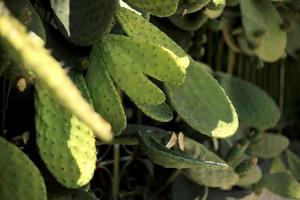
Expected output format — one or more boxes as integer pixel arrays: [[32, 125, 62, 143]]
[[35, 75, 96, 188]]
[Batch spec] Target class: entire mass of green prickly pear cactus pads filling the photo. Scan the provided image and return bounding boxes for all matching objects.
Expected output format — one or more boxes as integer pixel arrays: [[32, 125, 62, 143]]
[[0, 0, 300, 200]]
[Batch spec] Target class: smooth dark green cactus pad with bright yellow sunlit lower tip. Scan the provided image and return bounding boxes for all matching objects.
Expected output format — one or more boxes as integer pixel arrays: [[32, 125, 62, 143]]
[[165, 61, 238, 138]]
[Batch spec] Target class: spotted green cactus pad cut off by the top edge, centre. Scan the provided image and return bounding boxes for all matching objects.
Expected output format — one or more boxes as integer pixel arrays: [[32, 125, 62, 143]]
[[126, 0, 179, 17]]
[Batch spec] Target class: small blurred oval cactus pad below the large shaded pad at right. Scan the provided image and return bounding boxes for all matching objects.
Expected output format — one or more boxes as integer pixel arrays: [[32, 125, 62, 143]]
[[249, 133, 289, 159]]
